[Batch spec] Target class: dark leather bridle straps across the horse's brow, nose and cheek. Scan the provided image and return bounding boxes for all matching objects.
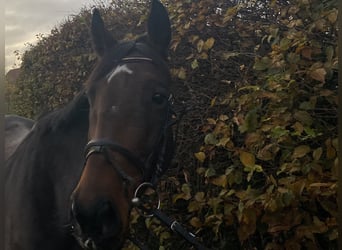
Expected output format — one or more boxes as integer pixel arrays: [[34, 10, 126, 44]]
[[84, 53, 176, 188]]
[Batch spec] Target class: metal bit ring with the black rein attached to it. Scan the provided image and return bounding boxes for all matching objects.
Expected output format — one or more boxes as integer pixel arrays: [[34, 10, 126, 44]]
[[129, 182, 209, 250]]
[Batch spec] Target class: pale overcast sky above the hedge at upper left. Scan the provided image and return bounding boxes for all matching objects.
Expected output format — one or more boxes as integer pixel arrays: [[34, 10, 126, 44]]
[[5, 0, 109, 72]]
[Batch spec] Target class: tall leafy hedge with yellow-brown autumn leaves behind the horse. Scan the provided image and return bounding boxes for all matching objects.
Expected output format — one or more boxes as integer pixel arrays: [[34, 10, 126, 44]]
[[8, 0, 338, 250]]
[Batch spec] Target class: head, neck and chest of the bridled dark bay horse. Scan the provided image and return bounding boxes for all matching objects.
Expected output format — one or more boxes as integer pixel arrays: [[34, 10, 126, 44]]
[[4, 0, 174, 250]]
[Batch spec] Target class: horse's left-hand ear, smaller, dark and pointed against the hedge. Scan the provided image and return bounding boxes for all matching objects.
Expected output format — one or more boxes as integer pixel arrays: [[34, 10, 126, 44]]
[[91, 8, 116, 57]]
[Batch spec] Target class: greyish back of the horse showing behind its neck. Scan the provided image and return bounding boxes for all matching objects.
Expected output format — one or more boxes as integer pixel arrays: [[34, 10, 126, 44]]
[[5, 115, 34, 160]]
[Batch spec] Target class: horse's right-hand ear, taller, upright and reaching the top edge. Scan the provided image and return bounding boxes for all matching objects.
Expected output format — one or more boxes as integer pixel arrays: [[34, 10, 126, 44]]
[[147, 0, 171, 57]]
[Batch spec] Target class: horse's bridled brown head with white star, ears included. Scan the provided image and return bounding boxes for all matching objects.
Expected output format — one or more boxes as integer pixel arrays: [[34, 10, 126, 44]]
[[71, 0, 173, 249]]
